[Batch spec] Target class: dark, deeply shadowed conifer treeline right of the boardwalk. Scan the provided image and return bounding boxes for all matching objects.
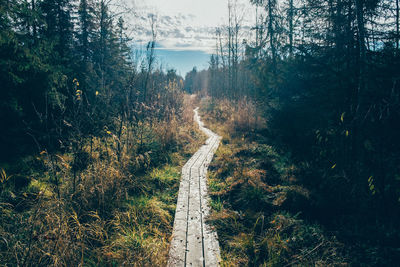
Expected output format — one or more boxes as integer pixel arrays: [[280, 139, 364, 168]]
[[192, 0, 400, 264]]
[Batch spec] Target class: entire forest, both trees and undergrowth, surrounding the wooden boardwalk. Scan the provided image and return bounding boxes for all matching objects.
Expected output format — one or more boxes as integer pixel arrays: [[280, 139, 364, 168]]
[[0, 0, 400, 266]]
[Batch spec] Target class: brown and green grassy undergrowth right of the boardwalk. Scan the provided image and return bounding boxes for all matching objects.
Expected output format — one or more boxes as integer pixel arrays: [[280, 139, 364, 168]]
[[201, 100, 348, 266]]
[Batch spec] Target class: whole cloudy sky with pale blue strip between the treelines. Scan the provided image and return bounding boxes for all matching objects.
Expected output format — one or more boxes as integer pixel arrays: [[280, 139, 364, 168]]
[[126, 0, 253, 76]]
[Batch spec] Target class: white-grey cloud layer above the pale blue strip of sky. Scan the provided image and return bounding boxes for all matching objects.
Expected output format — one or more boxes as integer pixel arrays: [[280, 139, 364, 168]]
[[132, 0, 256, 53]]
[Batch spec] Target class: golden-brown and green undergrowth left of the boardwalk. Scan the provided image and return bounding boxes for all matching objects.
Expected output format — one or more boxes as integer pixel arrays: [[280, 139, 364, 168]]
[[0, 96, 204, 266]]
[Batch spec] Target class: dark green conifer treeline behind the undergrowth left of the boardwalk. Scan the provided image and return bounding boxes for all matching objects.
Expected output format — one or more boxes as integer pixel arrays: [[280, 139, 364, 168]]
[[0, 0, 181, 159]]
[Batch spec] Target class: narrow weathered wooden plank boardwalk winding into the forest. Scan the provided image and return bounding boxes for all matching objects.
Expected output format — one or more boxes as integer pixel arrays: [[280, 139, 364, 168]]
[[168, 108, 221, 267]]
